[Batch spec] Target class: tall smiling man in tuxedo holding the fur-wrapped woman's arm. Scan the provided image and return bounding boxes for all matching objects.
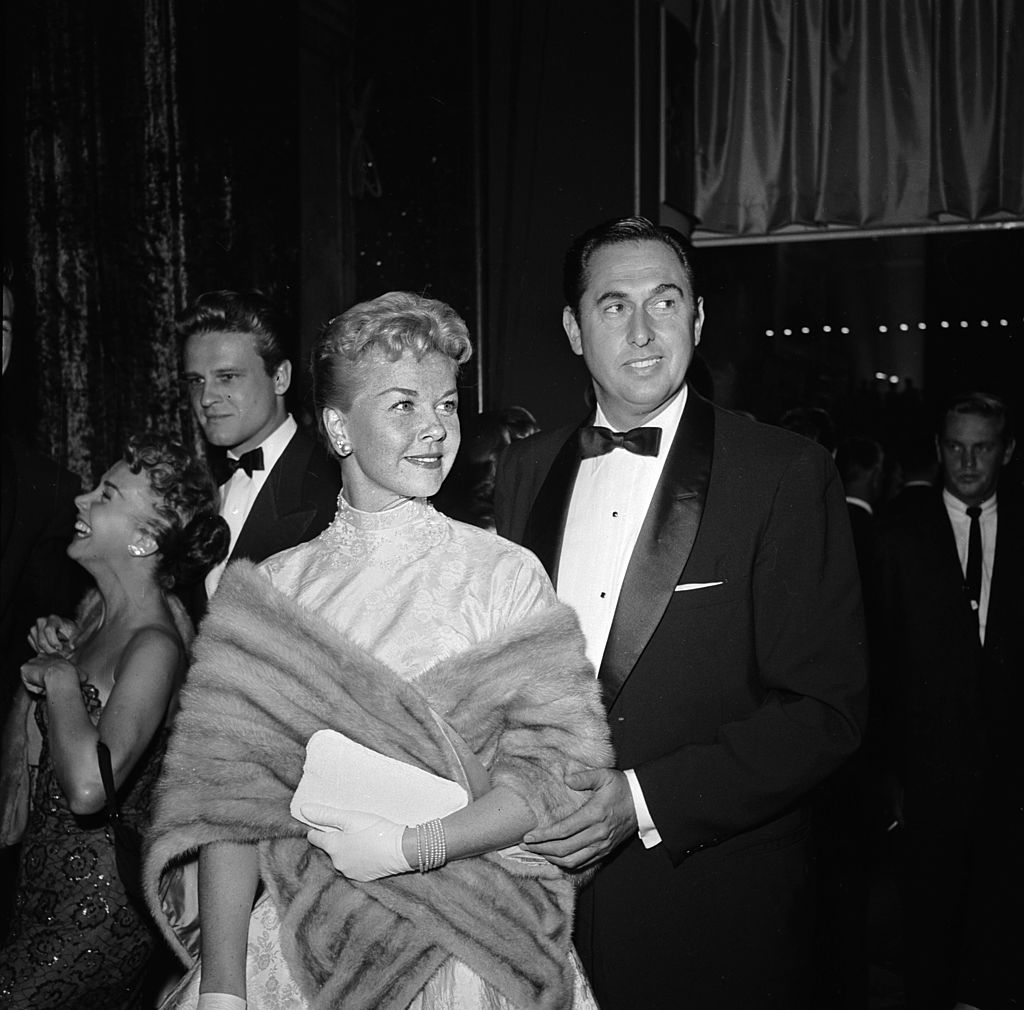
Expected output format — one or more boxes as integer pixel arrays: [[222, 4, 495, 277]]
[[496, 218, 865, 1010]]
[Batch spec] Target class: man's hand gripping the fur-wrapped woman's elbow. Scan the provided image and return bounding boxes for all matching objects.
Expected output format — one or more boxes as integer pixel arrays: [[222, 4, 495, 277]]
[[523, 768, 637, 870]]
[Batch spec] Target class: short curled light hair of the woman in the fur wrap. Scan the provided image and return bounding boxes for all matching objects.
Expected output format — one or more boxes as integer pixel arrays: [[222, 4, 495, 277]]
[[310, 291, 473, 452]]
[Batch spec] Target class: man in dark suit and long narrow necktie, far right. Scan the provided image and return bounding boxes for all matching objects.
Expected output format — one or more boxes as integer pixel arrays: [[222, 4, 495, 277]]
[[872, 393, 1024, 1010]]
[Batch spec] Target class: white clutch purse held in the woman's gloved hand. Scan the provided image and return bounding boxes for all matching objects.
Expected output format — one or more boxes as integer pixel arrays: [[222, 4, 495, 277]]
[[290, 729, 469, 828]]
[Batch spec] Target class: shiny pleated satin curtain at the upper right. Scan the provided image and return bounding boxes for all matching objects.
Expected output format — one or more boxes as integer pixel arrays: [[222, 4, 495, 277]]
[[694, 0, 1024, 235]]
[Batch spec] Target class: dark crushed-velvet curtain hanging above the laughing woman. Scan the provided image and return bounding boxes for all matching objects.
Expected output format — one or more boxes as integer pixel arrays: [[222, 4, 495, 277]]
[[11, 0, 298, 483]]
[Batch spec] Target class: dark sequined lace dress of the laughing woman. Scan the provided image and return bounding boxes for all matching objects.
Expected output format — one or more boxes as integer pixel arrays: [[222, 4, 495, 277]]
[[0, 684, 164, 1010]]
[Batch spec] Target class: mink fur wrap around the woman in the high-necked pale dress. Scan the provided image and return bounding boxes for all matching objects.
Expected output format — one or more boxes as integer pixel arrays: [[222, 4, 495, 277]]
[[145, 561, 613, 1010]]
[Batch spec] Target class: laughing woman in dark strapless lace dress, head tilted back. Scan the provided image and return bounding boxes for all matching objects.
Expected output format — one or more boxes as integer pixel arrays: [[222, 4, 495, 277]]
[[0, 435, 229, 1010]]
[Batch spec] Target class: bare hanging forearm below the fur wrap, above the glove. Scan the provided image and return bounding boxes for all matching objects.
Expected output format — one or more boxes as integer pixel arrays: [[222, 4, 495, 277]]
[[199, 842, 259, 1000]]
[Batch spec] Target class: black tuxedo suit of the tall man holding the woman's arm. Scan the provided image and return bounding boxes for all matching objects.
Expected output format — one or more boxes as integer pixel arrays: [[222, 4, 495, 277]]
[[496, 389, 866, 1010]]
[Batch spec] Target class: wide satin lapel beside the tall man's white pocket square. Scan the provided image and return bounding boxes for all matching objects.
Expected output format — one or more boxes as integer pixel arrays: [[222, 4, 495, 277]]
[[600, 389, 715, 709]]
